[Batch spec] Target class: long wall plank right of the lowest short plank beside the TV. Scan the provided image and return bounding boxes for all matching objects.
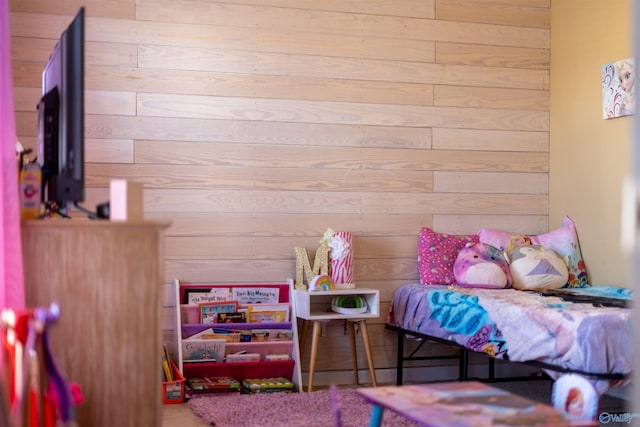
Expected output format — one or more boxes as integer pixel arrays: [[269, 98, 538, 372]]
[[130, 143, 549, 173]]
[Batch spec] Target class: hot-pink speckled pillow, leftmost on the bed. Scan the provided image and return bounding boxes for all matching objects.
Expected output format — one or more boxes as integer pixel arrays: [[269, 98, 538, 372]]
[[418, 227, 479, 285]]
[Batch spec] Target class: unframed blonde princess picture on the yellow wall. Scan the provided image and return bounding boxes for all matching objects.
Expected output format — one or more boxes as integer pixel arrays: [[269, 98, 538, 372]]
[[602, 58, 636, 120]]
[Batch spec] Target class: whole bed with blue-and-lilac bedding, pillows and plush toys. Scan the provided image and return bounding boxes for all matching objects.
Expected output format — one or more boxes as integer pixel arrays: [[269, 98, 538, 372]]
[[385, 216, 633, 393]]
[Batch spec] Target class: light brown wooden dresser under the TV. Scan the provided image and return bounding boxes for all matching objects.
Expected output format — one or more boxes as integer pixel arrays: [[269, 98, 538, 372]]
[[22, 219, 168, 427]]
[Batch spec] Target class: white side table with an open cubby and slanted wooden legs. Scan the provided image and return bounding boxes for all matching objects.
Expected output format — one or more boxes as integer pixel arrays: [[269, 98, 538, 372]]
[[293, 288, 380, 392]]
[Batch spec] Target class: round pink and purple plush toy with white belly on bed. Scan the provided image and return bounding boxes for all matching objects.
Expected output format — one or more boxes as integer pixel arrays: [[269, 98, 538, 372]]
[[453, 243, 511, 289]]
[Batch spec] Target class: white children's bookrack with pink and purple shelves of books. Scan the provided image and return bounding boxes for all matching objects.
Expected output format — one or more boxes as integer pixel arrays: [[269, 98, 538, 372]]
[[175, 280, 301, 390]]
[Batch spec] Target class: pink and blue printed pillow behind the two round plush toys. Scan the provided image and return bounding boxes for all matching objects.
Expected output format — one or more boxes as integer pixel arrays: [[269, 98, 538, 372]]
[[478, 216, 589, 288]]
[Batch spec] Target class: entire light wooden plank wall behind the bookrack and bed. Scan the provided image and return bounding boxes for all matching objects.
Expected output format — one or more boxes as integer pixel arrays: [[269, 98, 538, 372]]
[[10, 0, 550, 386]]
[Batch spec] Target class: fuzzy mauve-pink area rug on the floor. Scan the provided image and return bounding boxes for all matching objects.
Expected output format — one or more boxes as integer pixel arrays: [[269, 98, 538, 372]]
[[187, 389, 417, 427]]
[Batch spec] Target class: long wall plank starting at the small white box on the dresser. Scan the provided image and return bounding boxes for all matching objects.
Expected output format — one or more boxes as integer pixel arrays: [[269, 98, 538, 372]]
[[145, 189, 548, 215]]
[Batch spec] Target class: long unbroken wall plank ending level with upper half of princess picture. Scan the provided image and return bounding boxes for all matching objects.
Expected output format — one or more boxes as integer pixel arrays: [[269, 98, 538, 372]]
[[138, 45, 549, 89]]
